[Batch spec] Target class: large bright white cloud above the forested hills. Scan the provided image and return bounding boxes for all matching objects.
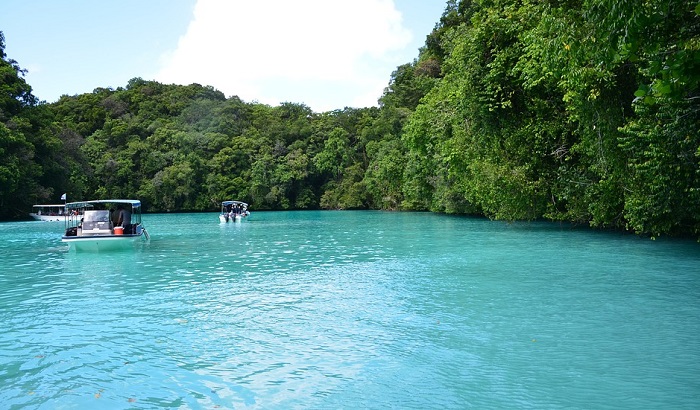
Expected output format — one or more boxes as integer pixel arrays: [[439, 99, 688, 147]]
[[156, 0, 411, 111]]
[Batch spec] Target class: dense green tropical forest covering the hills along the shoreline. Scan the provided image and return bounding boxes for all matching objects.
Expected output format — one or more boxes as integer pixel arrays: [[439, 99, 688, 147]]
[[0, 0, 700, 238]]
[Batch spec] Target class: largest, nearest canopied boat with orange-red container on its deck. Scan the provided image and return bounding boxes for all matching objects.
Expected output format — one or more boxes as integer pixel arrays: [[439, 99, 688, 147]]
[[61, 199, 150, 252]]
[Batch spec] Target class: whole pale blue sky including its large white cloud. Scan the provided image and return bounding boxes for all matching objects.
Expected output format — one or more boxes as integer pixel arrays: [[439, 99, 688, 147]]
[[0, 0, 447, 112]]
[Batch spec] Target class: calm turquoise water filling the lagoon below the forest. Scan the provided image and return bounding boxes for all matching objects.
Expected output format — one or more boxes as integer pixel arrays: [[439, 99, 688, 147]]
[[0, 211, 700, 409]]
